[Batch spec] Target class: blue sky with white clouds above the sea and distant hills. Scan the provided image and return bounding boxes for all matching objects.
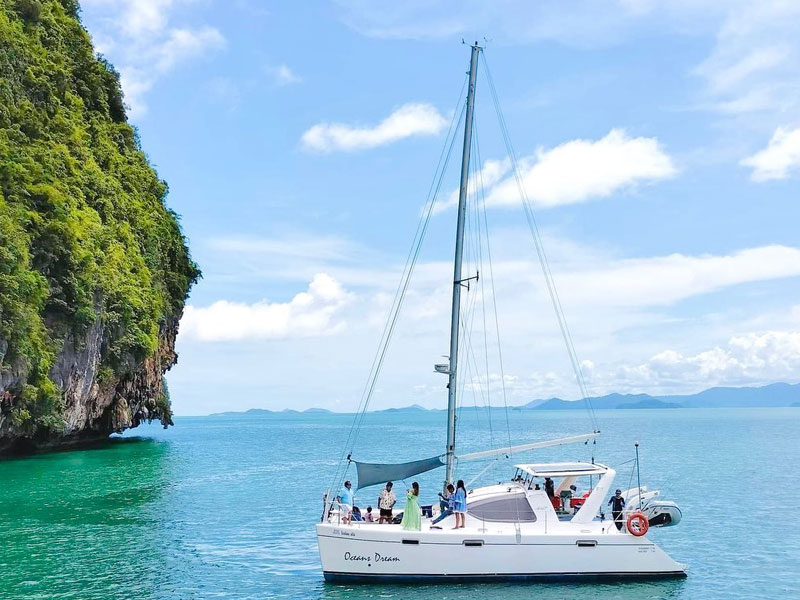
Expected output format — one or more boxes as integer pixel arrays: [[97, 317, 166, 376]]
[[82, 0, 800, 415]]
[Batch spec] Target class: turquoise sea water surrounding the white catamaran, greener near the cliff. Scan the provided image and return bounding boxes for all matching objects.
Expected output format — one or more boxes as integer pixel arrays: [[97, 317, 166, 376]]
[[0, 408, 800, 600]]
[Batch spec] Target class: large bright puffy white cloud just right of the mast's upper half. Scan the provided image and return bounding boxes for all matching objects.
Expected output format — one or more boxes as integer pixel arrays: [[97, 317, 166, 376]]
[[486, 129, 677, 207]]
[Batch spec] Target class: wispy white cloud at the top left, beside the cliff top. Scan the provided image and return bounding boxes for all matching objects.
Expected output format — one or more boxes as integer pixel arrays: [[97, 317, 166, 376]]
[[82, 0, 225, 118]]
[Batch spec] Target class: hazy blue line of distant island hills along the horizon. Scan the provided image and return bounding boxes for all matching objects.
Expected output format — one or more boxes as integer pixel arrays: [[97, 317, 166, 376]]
[[209, 383, 800, 417]]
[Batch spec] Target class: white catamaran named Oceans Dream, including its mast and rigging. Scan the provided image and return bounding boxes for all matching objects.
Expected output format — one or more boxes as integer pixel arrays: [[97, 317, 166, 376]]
[[316, 42, 685, 583]]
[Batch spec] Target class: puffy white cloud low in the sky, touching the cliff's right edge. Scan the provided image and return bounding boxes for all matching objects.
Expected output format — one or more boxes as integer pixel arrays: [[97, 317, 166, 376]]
[[180, 273, 350, 342]]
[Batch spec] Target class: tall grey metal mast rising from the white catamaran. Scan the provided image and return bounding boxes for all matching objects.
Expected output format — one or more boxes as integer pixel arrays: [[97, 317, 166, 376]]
[[444, 42, 481, 486]]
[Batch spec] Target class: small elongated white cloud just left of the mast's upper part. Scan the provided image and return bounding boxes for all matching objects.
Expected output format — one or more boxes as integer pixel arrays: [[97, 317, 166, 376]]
[[301, 103, 447, 152]]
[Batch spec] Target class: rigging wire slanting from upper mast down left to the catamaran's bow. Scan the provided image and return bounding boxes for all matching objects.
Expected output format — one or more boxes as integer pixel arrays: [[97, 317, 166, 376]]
[[329, 77, 467, 496]]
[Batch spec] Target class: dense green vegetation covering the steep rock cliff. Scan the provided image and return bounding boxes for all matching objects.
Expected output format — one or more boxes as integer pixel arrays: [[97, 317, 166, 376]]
[[0, 0, 199, 432]]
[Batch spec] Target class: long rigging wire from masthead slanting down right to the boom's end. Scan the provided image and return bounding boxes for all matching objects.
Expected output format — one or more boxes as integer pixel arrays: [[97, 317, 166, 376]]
[[481, 53, 599, 432]]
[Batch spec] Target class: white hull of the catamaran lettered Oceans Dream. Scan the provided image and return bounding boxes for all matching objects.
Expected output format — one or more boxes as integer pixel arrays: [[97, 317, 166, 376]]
[[317, 519, 685, 583]]
